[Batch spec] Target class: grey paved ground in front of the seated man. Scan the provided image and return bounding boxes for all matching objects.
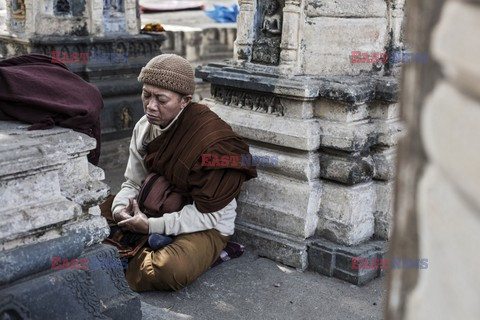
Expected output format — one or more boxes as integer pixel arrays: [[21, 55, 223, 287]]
[[141, 251, 385, 320]]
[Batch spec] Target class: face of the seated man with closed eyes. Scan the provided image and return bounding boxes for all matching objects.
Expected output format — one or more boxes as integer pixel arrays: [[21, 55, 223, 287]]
[[142, 84, 191, 127]]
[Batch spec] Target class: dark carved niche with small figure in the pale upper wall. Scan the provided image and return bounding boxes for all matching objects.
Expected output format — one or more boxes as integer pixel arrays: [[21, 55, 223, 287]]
[[252, 0, 284, 65]]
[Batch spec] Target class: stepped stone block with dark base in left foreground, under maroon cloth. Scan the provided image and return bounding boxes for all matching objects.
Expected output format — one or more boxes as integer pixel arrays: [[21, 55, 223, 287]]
[[0, 121, 141, 319]]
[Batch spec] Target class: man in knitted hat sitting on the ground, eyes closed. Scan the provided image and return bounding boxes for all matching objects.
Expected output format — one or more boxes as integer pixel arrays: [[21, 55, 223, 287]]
[[112, 54, 256, 291]]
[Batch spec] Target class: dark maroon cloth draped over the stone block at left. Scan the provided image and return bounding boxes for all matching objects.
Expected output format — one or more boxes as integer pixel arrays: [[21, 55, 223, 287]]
[[0, 54, 103, 164]]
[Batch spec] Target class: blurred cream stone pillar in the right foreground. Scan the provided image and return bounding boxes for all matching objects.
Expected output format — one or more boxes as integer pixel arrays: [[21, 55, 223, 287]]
[[387, 0, 480, 320]]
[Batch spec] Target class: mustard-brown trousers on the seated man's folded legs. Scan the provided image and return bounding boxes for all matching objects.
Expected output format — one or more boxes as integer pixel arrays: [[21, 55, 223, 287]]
[[126, 229, 230, 292]]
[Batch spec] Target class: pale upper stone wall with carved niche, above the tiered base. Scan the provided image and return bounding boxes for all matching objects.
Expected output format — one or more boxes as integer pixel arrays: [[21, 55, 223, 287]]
[[234, 0, 405, 76]]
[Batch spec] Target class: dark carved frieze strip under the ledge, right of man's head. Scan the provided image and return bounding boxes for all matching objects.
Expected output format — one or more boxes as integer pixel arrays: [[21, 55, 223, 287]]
[[211, 84, 284, 116]]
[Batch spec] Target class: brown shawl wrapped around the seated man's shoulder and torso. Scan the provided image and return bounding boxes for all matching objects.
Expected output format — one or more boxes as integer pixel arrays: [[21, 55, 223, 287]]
[[145, 103, 257, 213]]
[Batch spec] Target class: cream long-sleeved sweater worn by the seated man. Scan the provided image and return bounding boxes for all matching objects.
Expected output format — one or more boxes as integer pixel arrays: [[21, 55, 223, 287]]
[[112, 110, 237, 236]]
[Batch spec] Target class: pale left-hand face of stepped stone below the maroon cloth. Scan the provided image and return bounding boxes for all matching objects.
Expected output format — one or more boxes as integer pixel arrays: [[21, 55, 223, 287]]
[[0, 122, 81, 245]]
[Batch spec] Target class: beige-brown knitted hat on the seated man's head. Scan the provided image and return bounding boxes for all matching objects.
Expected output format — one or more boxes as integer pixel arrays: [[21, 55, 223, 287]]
[[138, 54, 195, 94]]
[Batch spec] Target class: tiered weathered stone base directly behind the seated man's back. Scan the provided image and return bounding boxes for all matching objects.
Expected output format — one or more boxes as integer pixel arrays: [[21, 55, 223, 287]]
[[197, 63, 402, 284]]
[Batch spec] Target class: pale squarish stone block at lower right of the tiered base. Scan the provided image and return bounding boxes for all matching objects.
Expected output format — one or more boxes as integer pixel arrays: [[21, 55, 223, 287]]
[[317, 181, 375, 245]]
